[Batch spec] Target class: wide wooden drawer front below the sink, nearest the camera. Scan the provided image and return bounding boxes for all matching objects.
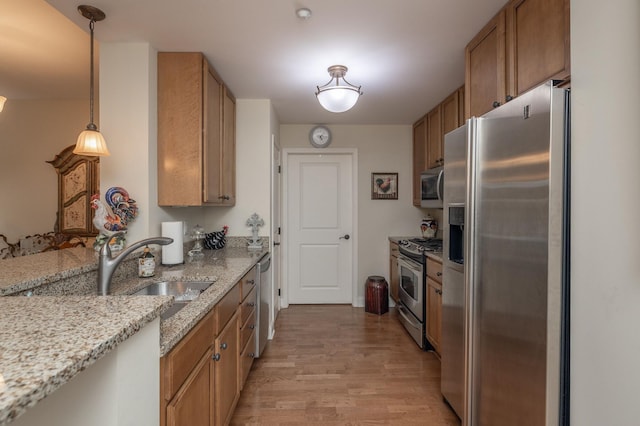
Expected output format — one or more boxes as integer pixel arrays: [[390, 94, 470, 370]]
[[160, 308, 216, 401]]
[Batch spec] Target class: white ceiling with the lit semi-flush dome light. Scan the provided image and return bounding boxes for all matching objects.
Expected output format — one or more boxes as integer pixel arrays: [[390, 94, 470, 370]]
[[0, 0, 506, 124]]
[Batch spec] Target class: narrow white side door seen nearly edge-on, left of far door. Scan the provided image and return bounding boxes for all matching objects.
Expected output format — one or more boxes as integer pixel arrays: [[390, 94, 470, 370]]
[[269, 135, 282, 339]]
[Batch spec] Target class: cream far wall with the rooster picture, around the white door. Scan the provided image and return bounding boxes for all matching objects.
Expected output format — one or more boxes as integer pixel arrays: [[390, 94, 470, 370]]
[[280, 125, 426, 303]]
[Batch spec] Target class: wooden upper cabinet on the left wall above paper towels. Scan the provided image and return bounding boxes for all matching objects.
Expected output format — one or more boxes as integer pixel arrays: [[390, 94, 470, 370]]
[[158, 52, 235, 206]]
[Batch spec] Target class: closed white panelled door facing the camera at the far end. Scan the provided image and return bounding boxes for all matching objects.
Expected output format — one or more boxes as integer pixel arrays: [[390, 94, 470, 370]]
[[285, 153, 355, 304]]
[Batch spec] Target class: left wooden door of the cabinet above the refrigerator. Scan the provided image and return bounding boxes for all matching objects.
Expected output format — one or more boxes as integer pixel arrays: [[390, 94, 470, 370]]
[[465, 10, 507, 117]]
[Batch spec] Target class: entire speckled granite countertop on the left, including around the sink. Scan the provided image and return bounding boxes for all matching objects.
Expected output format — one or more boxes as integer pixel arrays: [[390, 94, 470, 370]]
[[0, 238, 268, 425]]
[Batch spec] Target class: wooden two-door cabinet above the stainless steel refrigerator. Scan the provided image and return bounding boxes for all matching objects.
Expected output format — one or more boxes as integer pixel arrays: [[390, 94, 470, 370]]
[[465, 0, 571, 118]]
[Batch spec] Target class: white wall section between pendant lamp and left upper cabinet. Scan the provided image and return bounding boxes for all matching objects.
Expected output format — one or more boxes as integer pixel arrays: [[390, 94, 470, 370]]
[[100, 43, 205, 243]]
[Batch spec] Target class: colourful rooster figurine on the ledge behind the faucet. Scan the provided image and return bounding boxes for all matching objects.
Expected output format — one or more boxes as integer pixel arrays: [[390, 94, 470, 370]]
[[91, 186, 138, 250]]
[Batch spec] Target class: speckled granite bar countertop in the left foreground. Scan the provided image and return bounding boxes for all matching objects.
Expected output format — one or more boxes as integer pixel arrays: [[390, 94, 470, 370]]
[[0, 296, 172, 425]]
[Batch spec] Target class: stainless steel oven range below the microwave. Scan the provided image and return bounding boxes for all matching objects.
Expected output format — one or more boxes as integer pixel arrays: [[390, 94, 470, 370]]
[[397, 238, 442, 350]]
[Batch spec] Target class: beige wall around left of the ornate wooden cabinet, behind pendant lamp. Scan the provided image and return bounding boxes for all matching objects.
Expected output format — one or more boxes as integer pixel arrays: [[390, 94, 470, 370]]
[[0, 99, 89, 243]]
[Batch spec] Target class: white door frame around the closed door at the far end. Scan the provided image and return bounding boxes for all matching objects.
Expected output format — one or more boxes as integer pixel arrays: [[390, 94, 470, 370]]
[[280, 148, 358, 308]]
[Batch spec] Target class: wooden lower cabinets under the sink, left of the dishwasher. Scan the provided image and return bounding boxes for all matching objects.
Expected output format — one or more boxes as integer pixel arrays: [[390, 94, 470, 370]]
[[160, 268, 257, 426]]
